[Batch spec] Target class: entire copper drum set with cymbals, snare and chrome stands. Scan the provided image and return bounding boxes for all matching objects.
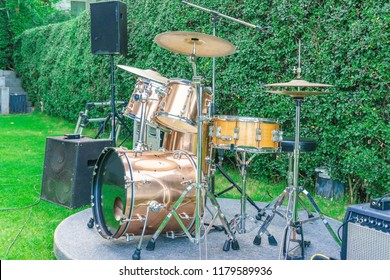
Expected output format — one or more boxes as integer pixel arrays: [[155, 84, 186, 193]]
[[87, 3, 340, 259]]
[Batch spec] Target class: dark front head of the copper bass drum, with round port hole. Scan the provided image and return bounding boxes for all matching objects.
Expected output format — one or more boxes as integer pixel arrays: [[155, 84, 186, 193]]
[[92, 149, 127, 239]]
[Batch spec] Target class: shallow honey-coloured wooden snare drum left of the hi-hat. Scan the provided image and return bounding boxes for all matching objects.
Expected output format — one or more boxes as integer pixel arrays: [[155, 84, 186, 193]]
[[212, 116, 282, 152]]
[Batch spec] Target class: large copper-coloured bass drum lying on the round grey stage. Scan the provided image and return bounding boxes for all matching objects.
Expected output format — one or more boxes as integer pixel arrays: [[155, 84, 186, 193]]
[[92, 148, 196, 239]]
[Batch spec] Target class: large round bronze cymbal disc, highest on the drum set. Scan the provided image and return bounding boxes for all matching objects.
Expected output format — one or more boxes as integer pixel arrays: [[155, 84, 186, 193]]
[[154, 31, 236, 57]]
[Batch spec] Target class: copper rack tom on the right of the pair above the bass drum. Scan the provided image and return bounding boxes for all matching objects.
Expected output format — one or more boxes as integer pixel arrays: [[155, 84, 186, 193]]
[[155, 79, 212, 133]]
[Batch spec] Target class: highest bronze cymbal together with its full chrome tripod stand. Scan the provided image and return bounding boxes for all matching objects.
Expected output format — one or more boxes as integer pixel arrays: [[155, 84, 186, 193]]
[[151, 31, 239, 257]]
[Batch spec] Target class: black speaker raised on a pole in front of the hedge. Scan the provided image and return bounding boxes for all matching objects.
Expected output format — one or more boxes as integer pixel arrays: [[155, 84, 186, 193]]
[[90, 1, 127, 55]]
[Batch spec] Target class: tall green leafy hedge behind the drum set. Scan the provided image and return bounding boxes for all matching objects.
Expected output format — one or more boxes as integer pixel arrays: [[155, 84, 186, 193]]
[[14, 0, 390, 201]]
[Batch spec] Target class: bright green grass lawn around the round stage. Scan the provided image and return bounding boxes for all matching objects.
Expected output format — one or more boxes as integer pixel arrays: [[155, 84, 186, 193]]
[[0, 113, 346, 260]]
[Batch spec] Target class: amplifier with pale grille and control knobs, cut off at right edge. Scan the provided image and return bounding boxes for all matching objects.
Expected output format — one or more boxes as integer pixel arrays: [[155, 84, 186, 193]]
[[341, 203, 390, 260]]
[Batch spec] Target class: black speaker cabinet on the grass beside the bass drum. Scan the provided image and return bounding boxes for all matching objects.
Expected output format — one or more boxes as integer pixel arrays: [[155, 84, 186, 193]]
[[41, 136, 111, 209]]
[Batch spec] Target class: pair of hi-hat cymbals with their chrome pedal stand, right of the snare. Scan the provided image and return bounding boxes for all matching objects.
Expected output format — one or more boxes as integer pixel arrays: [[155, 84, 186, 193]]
[[254, 41, 341, 259]]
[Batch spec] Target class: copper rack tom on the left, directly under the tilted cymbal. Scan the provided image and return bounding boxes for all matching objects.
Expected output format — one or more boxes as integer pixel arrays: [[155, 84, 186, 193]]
[[124, 78, 166, 127]]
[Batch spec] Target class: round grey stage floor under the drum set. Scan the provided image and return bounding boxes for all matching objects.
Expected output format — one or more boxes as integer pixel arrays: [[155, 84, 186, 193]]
[[54, 199, 341, 260]]
